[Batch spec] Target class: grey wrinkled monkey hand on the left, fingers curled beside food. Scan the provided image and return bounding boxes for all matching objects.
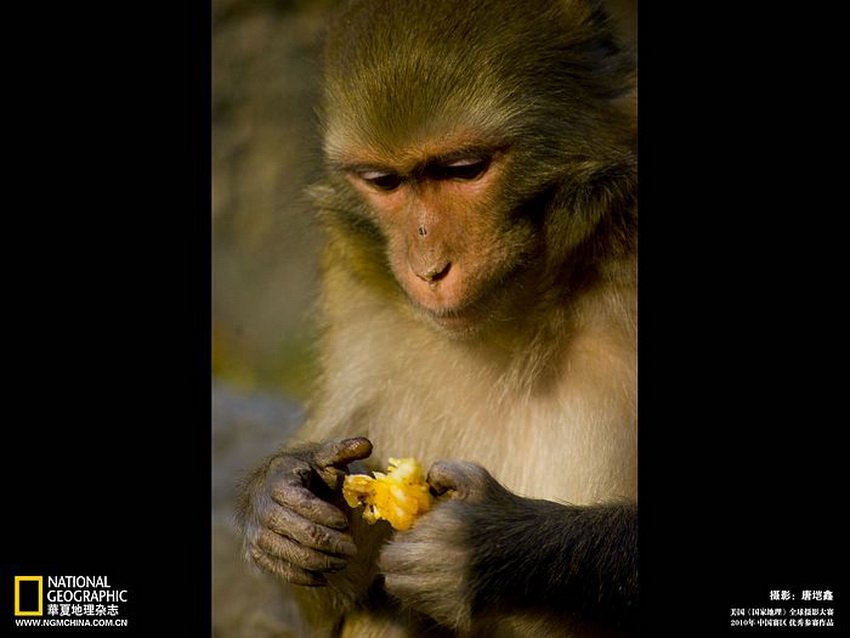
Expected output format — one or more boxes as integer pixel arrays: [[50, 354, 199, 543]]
[[239, 437, 372, 586]]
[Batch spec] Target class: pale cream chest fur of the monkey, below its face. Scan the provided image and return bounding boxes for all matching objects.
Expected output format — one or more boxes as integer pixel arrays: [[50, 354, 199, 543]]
[[311, 278, 636, 504]]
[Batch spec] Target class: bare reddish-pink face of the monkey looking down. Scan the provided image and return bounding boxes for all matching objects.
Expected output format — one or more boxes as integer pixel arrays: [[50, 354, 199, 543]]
[[332, 142, 534, 334]]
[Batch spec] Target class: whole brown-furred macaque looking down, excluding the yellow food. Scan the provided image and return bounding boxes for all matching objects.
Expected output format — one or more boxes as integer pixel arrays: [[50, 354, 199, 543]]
[[235, 0, 637, 637]]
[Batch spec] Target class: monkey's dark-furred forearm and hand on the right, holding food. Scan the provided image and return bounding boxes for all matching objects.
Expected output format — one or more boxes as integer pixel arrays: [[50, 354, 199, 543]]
[[381, 462, 638, 629]]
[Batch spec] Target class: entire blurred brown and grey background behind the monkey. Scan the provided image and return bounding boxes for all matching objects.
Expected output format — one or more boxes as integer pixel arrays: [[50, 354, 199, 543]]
[[211, 0, 635, 638]]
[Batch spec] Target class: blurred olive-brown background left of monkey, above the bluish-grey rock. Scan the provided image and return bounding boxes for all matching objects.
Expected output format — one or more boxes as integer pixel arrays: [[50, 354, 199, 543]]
[[212, 0, 333, 398]]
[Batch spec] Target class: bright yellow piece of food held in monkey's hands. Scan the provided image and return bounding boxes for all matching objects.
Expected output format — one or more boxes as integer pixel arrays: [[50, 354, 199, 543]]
[[342, 458, 431, 531]]
